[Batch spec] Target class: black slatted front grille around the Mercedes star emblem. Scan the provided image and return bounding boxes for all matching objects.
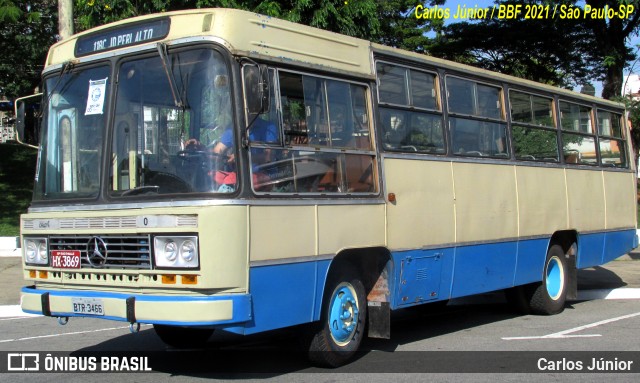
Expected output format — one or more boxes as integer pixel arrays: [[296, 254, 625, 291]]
[[49, 235, 151, 270]]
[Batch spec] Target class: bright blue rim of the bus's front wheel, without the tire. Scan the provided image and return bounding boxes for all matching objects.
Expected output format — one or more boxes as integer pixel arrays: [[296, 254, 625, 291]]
[[329, 283, 360, 346]]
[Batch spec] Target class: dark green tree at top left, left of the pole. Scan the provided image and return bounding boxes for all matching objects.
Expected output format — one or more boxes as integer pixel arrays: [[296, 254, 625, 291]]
[[0, 0, 57, 99]]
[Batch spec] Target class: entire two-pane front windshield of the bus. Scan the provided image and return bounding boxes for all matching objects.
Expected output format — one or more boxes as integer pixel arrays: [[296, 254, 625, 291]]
[[36, 48, 238, 199]]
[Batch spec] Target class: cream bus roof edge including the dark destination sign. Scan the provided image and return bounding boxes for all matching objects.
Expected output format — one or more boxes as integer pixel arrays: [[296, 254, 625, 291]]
[[45, 8, 624, 108]]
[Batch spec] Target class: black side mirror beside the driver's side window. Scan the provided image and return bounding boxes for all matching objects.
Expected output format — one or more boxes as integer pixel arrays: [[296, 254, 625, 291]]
[[242, 64, 271, 119]]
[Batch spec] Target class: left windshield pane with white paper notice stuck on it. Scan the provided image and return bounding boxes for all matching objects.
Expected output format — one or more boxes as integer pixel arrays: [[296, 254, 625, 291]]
[[34, 65, 111, 201]]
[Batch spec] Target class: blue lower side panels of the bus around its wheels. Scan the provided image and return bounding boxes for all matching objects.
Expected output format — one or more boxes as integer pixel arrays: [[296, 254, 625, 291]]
[[218, 230, 637, 334]]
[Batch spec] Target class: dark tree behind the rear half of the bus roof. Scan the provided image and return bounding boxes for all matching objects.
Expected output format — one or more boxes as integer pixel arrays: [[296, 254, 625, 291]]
[[433, 0, 640, 99]]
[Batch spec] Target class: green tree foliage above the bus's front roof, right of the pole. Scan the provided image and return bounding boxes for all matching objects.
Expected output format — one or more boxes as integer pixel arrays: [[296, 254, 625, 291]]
[[75, 0, 444, 44]]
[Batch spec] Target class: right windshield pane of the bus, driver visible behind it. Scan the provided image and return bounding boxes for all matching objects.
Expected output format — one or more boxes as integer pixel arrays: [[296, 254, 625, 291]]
[[109, 49, 237, 197]]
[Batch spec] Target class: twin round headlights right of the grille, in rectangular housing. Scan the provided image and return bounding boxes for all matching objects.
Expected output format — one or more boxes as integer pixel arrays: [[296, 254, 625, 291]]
[[153, 236, 200, 268]]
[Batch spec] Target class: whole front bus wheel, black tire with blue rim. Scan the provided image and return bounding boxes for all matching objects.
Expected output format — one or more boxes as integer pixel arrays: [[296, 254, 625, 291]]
[[309, 269, 367, 367]]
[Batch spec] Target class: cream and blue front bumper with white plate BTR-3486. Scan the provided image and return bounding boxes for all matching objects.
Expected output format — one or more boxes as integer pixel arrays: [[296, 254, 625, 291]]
[[20, 286, 252, 327]]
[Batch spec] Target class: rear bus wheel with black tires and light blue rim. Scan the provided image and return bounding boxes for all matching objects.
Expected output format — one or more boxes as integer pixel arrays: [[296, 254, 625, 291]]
[[506, 245, 569, 315]]
